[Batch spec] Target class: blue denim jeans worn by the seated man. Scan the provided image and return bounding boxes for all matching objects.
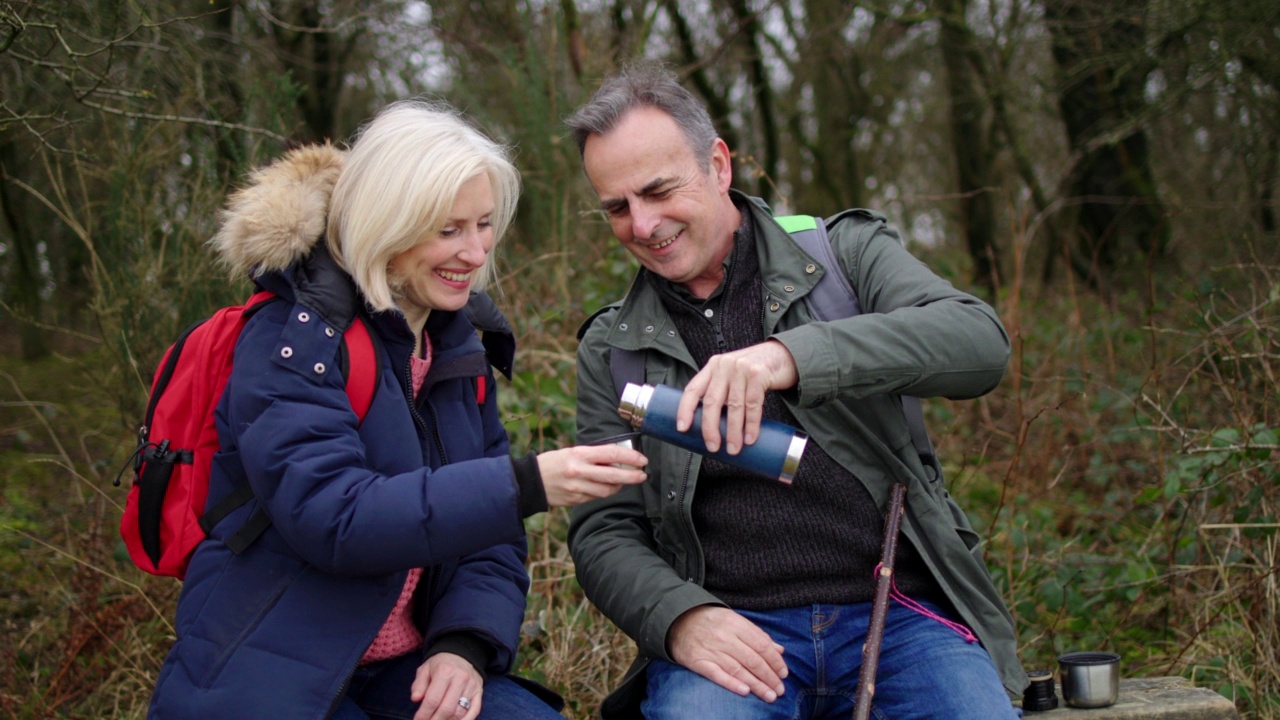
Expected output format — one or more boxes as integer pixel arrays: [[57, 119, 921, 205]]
[[641, 602, 1021, 720]]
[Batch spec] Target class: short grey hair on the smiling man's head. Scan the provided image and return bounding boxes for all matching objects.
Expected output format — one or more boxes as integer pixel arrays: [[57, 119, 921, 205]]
[[564, 61, 719, 170]]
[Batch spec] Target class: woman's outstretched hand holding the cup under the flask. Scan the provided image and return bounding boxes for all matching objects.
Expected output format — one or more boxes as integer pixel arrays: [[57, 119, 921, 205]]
[[538, 445, 649, 507]]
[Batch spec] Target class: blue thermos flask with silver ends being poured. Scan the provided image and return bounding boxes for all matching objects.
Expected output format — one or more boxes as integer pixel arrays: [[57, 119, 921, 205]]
[[618, 383, 809, 484]]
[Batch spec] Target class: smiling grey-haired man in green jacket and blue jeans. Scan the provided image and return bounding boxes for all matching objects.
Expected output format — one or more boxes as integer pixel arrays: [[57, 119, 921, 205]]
[[568, 65, 1027, 720]]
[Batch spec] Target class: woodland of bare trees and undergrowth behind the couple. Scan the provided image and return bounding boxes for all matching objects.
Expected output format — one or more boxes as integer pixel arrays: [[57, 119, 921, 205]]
[[0, 0, 1280, 719]]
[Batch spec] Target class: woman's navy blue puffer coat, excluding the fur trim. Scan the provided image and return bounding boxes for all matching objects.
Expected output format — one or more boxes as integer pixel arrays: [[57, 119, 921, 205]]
[[150, 142, 529, 720]]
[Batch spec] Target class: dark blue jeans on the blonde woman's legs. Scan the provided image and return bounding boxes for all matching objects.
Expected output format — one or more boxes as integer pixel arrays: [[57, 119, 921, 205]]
[[330, 652, 564, 720]]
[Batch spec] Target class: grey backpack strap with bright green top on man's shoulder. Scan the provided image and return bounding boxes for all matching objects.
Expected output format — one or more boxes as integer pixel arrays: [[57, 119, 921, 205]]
[[773, 215, 937, 466]]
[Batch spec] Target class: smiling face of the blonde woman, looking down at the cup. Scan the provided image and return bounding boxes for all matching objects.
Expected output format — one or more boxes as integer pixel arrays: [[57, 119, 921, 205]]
[[388, 173, 494, 314]]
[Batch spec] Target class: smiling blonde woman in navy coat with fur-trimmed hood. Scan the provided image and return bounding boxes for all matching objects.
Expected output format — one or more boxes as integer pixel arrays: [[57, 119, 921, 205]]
[[150, 101, 645, 720]]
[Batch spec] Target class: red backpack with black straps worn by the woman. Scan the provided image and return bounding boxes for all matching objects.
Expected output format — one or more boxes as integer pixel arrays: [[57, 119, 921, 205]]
[[115, 291, 378, 579]]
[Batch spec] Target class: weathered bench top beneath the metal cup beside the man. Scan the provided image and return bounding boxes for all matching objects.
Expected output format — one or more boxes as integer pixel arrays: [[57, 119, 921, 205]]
[[1024, 678, 1240, 720]]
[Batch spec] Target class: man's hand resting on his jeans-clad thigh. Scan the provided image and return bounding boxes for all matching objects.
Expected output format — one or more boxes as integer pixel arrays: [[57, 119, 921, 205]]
[[667, 605, 787, 702]]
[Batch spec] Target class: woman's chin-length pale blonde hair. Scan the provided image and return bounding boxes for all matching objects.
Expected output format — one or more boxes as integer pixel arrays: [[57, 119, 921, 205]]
[[328, 100, 520, 310]]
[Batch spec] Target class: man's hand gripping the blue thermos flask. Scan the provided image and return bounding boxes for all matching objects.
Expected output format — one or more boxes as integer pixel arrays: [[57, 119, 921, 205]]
[[676, 340, 800, 455]]
